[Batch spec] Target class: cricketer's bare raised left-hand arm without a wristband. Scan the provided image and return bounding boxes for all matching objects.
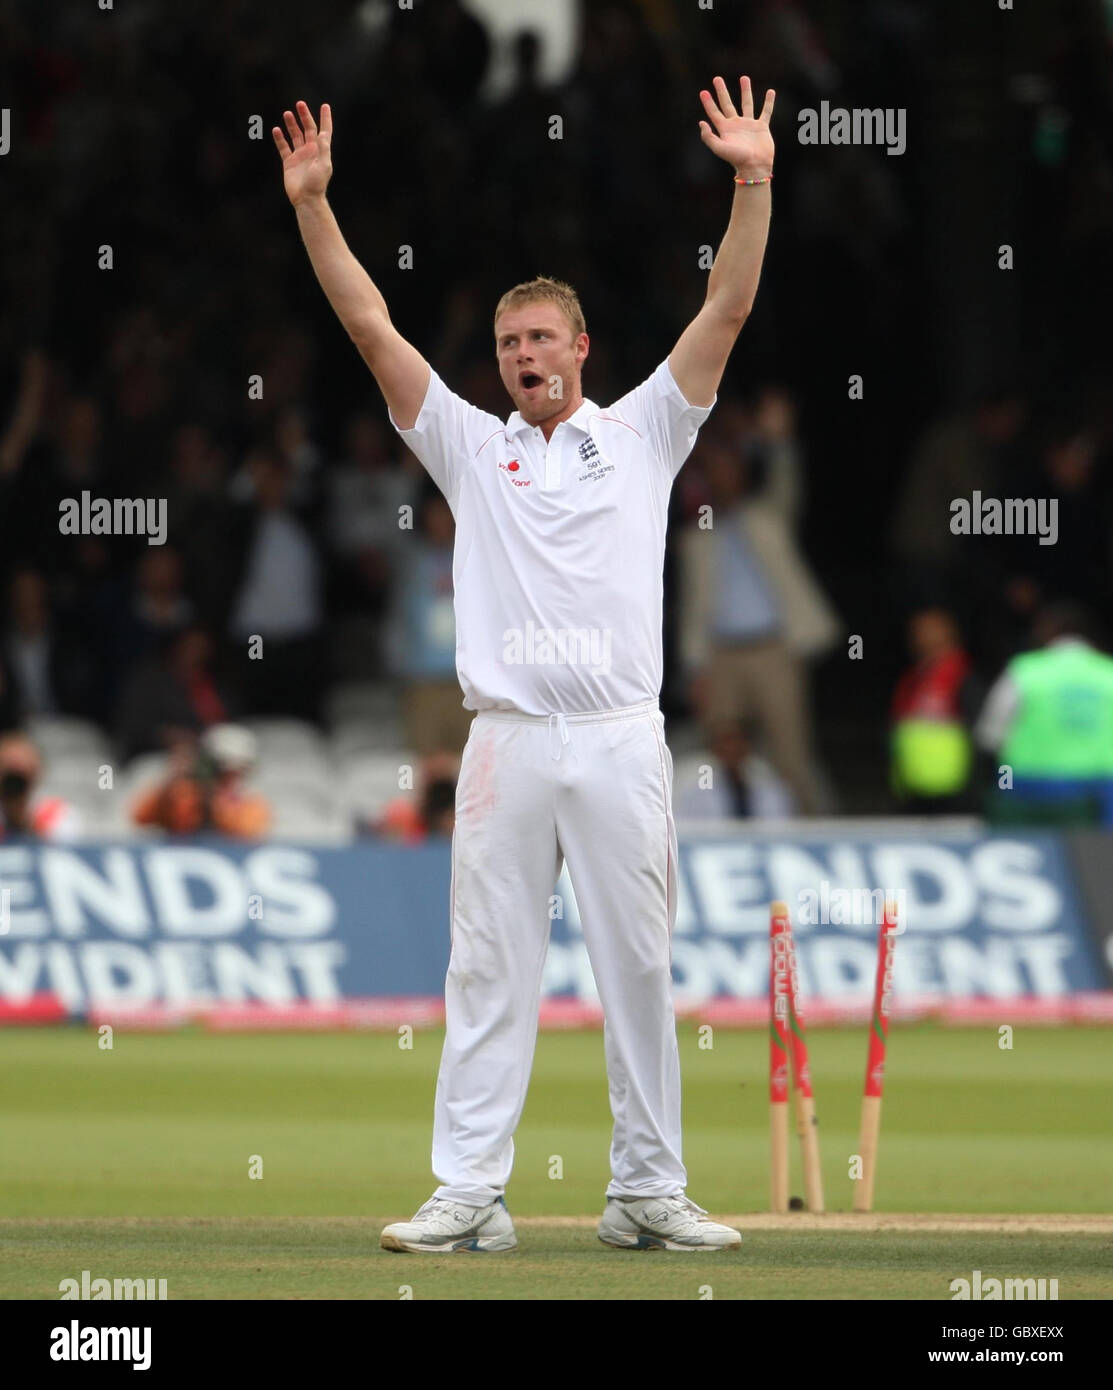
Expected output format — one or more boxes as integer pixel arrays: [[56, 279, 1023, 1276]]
[[271, 101, 429, 430]]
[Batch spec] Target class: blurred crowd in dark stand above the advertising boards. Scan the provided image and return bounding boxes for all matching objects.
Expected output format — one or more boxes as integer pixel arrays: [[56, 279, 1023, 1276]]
[[0, 0, 1113, 842]]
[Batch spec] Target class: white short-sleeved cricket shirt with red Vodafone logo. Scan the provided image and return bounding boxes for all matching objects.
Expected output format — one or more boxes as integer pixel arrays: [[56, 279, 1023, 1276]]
[[390, 360, 718, 714]]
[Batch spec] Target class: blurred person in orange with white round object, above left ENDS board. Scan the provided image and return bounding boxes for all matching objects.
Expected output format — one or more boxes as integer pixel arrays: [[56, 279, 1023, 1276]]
[[132, 724, 271, 840]]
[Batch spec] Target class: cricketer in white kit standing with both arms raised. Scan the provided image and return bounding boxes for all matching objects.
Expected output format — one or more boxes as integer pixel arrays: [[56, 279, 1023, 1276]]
[[272, 78, 774, 1251]]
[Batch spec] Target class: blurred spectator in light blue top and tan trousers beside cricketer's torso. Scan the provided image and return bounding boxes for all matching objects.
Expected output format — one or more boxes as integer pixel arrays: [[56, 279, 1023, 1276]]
[[390, 485, 474, 755]]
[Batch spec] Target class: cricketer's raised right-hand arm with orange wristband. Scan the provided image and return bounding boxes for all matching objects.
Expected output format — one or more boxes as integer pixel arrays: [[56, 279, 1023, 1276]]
[[668, 78, 774, 406]]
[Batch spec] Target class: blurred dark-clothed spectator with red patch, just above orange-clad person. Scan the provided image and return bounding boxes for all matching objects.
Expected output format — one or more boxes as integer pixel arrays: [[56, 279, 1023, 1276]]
[[117, 624, 229, 759]]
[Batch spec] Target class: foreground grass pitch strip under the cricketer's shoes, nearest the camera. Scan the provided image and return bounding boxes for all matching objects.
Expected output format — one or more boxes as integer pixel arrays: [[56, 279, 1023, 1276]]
[[8, 1216, 1113, 1311]]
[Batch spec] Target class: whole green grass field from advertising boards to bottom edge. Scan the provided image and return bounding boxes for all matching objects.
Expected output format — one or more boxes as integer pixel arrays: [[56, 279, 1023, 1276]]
[[0, 1008, 1113, 1298]]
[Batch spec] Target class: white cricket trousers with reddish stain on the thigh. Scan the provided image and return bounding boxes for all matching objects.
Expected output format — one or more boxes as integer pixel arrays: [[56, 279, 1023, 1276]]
[[432, 702, 688, 1205]]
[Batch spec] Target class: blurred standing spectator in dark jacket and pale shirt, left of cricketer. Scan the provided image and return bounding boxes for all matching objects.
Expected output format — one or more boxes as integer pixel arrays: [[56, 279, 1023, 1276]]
[[228, 449, 324, 719]]
